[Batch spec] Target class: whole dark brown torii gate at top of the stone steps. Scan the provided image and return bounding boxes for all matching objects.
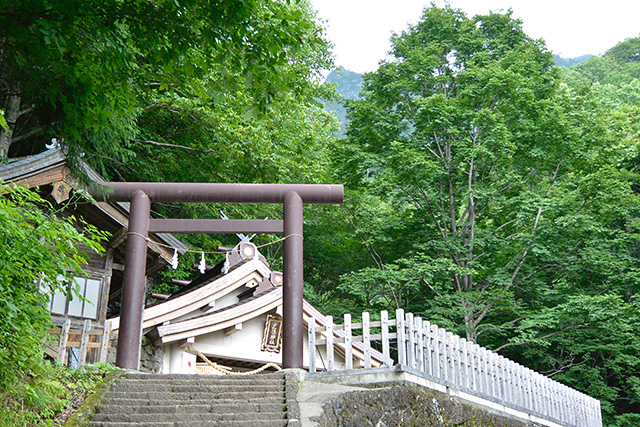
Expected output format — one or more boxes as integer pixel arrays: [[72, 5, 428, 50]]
[[91, 182, 344, 370]]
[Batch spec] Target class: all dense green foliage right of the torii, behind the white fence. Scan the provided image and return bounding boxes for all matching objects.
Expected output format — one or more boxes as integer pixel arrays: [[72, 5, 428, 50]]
[[307, 7, 640, 426]]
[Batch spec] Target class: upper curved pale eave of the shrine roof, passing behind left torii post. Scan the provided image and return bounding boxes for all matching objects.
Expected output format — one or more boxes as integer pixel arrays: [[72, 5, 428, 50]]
[[110, 259, 271, 330]]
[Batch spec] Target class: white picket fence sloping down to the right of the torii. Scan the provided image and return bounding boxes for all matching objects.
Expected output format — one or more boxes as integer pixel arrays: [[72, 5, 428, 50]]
[[309, 310, 602, 427]]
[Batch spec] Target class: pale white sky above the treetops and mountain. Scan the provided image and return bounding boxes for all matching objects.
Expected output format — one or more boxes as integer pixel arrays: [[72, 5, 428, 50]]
[[311, 0, 640, 73]]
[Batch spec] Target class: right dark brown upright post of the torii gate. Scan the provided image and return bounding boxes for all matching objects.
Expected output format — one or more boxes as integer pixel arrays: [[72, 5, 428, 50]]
[[282, 192, 304, 369]]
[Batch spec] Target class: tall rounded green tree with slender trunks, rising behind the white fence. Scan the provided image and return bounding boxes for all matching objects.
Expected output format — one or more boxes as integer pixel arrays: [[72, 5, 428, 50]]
[[340, 7, 568, 340]]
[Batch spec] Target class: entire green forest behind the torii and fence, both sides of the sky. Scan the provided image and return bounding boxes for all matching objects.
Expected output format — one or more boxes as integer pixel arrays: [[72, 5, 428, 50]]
[[0, 0, 640, 426]]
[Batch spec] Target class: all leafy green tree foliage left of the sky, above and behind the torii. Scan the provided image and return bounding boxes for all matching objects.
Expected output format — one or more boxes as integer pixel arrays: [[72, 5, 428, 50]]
[[0, 0, 336, 270]]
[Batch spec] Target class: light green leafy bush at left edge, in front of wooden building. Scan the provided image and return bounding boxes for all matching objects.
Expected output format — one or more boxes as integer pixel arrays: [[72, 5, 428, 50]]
[[0, 184, 105, 392]]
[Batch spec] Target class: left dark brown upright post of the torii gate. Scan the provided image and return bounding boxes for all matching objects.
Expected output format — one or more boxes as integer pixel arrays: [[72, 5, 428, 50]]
[[116, 190, 151, 370]]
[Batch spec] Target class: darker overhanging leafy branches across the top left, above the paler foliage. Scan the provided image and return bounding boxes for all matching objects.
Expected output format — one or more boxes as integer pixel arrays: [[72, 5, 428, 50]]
[[0, 0, 326, 171]]
